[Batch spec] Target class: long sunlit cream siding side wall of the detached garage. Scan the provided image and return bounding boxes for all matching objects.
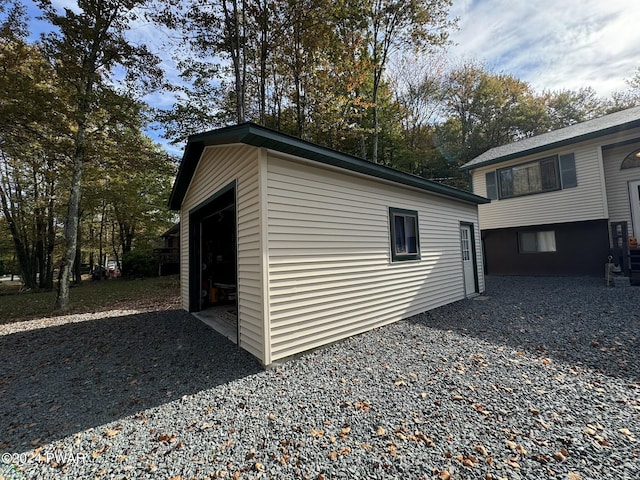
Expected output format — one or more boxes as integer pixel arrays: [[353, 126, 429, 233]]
[[266, 154, 484, 361]]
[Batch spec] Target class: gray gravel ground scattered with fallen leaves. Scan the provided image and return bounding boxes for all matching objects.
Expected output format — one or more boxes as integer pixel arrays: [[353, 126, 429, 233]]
[[0, 277, 640, 480]]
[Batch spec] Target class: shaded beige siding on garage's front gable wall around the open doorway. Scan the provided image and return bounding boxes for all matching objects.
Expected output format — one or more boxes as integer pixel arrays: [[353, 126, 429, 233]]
[[180, 145, 264, 359]]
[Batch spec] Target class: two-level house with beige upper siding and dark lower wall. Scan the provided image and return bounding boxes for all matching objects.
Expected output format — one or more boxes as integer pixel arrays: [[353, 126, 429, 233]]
[[462, 107, 640, 280]]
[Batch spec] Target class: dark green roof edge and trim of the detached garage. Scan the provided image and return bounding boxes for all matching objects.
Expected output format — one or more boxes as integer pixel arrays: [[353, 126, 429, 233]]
[[169, 122, 490, 210]]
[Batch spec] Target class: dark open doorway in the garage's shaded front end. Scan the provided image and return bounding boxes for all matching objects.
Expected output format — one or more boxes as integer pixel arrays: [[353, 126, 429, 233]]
[[189, 182, 238, 343]]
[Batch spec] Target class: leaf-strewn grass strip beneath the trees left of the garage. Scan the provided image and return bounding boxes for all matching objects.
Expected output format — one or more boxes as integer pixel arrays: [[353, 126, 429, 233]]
[[0, 275, 180, 323]]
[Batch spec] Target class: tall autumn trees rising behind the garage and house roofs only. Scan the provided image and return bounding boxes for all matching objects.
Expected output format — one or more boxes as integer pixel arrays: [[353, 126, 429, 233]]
[[154, 0, 640, 174]]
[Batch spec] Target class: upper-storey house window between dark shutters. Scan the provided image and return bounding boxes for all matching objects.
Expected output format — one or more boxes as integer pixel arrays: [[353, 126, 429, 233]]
[[498, 155, 560, 198]]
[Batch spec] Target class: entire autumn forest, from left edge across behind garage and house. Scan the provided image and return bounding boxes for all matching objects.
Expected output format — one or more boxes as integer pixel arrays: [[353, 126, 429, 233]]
[[0, 0, 640, 310]]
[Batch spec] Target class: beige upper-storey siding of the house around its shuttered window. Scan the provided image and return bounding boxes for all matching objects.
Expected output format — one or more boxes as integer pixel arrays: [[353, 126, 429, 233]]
[[472, 143, 607, 230]]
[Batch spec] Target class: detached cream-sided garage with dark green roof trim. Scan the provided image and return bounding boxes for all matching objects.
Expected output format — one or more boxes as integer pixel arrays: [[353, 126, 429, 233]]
[[169, 123, 488, 365]]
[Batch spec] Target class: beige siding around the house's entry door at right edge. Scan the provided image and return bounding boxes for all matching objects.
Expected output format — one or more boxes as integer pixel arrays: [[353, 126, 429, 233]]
[[603, 140, 640, 236]]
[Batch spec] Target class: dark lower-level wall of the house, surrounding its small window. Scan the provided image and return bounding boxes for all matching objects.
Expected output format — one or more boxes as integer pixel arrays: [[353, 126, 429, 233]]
[[482, 220, 609, 275]]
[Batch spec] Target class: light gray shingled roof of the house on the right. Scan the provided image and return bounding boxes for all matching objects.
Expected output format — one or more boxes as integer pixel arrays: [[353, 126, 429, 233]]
[[461, 107, 640, 170]]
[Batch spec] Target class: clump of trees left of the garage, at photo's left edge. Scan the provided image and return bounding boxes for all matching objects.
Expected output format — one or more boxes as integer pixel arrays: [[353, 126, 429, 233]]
[[0, 0, 175, 309]]
